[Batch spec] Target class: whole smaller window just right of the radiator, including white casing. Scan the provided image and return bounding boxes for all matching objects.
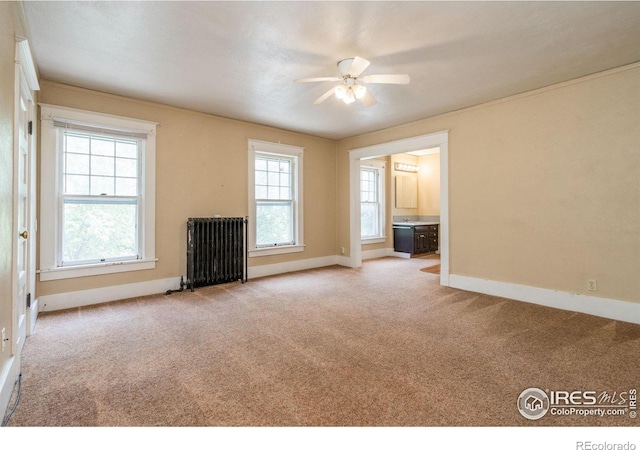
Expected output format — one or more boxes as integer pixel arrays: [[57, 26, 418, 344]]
[[249, 139, 304, 256]]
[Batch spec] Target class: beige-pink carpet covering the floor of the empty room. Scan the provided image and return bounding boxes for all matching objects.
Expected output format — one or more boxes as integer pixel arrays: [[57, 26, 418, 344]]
[[9, 258, 640, 427]]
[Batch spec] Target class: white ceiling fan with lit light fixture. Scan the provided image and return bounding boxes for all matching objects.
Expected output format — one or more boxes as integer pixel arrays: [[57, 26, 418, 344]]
[[294, 56, 410, 107]]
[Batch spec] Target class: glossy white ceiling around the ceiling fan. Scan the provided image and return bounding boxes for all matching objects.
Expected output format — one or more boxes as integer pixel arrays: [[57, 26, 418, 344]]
[[24, 1, 640, 139]]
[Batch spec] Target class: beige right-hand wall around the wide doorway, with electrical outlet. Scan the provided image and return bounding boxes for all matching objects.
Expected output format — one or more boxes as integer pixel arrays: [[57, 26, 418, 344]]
[[337, 64, 640, 302]]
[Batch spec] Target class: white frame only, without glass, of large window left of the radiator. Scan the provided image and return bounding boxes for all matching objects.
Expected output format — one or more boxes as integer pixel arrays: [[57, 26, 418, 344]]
[[38, 104, 158, 281]]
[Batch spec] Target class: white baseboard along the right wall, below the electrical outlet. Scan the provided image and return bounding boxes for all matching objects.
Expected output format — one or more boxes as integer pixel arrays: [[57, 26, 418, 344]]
[[449, 274, 640, 324]]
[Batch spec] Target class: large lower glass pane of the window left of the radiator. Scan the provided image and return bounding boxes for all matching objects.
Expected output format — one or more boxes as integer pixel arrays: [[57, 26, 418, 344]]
[[62, 203, 138, 263]]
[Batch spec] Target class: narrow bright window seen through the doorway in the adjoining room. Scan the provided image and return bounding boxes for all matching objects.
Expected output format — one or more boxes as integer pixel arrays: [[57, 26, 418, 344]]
[[360, 160, 385, 243]]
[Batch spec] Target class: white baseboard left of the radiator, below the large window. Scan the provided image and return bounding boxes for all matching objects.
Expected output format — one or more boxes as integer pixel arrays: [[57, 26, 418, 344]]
[[38, 277, 180, 312]]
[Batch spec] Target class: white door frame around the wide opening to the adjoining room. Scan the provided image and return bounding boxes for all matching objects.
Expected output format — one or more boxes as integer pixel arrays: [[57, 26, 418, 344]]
[[349, 130, 449, 286]]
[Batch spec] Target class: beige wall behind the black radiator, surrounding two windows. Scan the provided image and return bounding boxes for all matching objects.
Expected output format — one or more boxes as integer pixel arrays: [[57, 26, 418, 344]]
[[37, 81, 336, 296]]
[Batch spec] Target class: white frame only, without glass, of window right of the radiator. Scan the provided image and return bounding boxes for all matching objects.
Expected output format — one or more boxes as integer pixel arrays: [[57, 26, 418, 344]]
[[248, 139, 304, 258]]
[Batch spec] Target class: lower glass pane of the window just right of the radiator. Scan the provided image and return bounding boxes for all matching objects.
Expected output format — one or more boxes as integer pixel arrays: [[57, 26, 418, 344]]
[[256, 202, 294, 246]]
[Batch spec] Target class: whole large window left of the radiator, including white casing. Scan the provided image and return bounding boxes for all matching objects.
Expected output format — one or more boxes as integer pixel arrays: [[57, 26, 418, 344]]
[[39, 105, 156, 281]]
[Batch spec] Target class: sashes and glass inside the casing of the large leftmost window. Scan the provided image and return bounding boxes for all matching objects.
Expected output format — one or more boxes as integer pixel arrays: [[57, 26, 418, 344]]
[[58, 128, 142, 267]]
